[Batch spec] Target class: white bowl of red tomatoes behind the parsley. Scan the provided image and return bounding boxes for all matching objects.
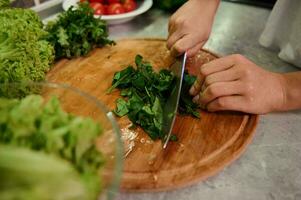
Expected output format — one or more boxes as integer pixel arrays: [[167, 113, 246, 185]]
[[63, 0, 153, 24]]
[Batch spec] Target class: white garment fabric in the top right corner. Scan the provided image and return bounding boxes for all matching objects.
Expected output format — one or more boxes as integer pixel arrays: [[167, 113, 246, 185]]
[[259, 0, 301, 67]]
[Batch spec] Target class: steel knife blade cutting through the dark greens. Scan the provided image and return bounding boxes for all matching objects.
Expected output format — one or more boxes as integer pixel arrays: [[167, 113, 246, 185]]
[[162, 52, 187, 149]]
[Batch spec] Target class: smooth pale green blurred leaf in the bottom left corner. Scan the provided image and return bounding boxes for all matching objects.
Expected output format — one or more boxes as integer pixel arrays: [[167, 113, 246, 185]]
[[0, 145, 89, 200]]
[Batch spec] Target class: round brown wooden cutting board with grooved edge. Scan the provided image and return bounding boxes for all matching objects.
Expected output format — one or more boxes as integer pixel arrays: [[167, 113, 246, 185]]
[[47, 39, 258, 191]]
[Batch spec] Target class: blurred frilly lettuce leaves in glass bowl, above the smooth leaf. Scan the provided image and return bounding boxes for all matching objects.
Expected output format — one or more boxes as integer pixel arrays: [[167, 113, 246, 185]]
[[0, 95, 104, 199]]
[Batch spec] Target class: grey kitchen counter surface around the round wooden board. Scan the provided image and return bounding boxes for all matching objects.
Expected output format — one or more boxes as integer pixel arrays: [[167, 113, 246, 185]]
[[110, 2, 301, 200]]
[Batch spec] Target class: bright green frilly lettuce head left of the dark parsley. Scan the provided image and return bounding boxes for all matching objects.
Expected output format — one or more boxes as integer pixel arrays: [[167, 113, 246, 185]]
[[0, 8, 54, 96]]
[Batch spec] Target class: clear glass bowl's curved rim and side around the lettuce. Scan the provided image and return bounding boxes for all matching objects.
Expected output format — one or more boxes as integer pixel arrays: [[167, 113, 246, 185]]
[[0, 82, 123, 200]]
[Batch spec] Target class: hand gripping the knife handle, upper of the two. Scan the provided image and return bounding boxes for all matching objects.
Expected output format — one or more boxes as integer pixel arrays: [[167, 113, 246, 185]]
[[167, 0, 219, 57]]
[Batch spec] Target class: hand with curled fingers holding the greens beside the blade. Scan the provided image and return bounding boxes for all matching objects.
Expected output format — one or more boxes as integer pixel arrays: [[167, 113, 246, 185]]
[[190, 55, 284, 114]]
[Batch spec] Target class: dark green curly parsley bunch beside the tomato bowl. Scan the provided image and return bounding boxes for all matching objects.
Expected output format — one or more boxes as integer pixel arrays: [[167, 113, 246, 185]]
[[46, 2, 114, 59]]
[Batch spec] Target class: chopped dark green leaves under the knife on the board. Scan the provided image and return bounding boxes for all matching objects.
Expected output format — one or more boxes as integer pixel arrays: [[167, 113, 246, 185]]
[[107, 55, 200, 140]]
